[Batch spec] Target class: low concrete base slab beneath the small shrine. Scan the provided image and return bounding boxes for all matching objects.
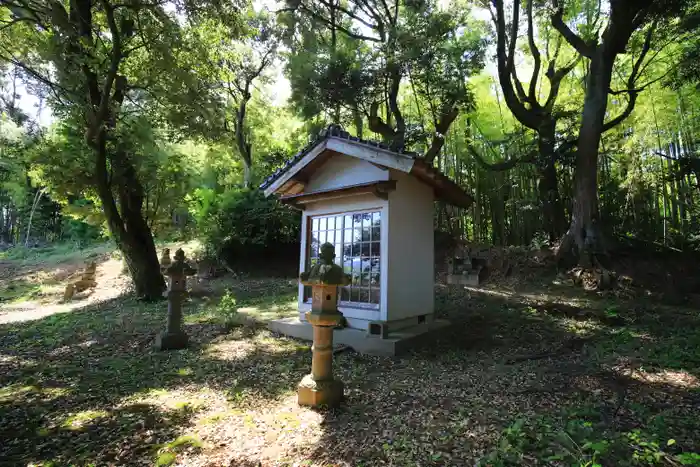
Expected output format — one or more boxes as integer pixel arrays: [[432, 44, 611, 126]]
[[268, 318, 450, 357]]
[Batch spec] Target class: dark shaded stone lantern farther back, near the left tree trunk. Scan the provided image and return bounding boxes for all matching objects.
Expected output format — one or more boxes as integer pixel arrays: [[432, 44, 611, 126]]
[[156, 249, 197, 350]]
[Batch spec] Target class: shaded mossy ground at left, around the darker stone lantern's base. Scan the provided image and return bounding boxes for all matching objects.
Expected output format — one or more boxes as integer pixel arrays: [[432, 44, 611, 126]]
[[0, 297, 308, 465]]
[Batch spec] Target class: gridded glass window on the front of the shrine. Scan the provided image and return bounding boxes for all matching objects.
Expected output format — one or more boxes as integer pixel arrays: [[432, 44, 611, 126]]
[[304, 211, 382, 308]]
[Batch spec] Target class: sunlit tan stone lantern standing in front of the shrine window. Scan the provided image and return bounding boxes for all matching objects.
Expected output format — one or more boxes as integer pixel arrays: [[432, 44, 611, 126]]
[[297, 243, 350, 407]]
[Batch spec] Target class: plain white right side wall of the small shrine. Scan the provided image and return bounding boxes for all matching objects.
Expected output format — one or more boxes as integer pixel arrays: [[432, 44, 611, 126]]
[[385, 171, 435, 321]]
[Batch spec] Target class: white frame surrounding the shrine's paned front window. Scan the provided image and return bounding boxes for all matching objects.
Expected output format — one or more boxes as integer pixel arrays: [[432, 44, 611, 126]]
[[298, 194, 389, 331]]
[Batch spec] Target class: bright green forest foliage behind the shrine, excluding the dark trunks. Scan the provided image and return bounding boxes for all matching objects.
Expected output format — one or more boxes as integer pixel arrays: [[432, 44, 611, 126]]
[[0, 0, 700, 257]]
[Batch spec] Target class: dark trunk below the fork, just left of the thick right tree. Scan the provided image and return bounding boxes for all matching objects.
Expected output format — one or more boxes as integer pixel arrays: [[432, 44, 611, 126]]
[[537, 120, 566, 242]]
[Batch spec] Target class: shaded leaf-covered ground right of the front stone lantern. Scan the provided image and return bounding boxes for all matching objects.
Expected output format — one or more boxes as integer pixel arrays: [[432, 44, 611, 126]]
[[304, 289, 700, 466]]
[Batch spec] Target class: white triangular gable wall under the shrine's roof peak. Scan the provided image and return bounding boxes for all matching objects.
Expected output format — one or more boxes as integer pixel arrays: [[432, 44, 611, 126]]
[[304, 154, 389, 192]]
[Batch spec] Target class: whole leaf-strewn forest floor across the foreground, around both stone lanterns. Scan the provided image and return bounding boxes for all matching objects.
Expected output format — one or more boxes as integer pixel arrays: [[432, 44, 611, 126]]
[[0, 285, 700, 466]]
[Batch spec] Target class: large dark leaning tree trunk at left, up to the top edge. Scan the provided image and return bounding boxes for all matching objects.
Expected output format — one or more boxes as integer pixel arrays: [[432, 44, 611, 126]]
[[62, 0, 165, 300]]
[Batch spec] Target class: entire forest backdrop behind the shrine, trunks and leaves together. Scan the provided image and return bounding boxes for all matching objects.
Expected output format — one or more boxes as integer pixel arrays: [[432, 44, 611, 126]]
[[0, 0, 700, 292]]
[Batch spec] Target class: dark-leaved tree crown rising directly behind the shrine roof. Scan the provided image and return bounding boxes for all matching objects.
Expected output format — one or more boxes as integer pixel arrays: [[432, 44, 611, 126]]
[[281, 0, 486, 149]]
